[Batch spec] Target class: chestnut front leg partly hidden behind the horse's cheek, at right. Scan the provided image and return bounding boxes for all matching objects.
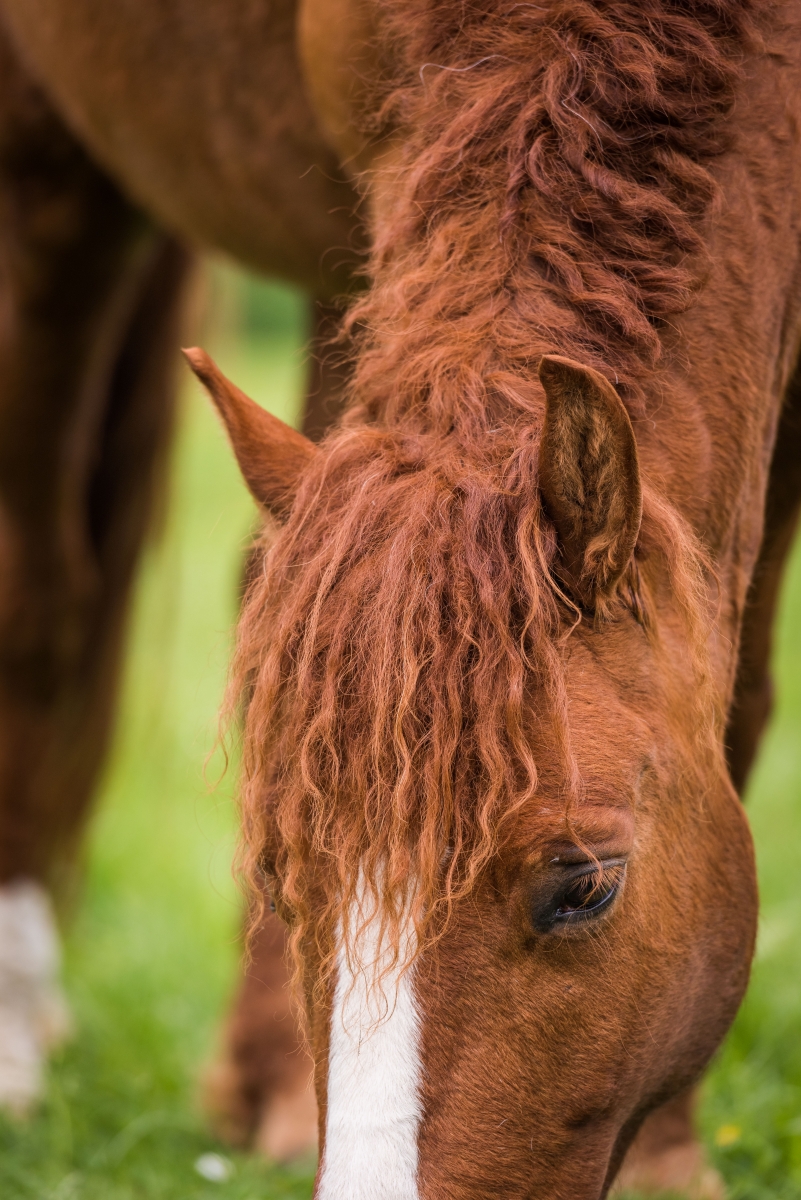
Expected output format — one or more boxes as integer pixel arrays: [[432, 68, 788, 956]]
[[616, 368, 801, 1200]]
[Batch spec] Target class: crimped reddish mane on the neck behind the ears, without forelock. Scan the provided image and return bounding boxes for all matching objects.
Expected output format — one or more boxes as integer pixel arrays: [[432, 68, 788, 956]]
[[335, 0, 751, 410]]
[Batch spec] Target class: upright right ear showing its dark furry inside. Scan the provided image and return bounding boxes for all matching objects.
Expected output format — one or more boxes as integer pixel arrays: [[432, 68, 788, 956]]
[[540, 354, 643, 610]]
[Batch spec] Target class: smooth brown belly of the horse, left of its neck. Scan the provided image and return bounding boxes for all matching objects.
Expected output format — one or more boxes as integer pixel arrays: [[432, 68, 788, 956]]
[[0, 0, 356, 295]]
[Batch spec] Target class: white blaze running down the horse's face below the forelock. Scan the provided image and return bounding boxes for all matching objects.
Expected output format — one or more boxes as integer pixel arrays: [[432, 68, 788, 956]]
[[317, 883, 422, 1200]]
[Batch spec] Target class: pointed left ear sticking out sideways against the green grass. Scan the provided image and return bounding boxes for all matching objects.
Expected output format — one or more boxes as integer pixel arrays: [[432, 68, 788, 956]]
[[183, 347, 318, 516]]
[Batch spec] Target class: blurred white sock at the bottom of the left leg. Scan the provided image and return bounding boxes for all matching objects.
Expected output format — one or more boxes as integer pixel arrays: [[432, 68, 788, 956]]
[[0, 880, 70, 1115]]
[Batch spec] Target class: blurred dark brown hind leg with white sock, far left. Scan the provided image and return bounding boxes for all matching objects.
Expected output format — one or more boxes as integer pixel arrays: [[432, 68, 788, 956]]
[[0, 28, 187, 1110]]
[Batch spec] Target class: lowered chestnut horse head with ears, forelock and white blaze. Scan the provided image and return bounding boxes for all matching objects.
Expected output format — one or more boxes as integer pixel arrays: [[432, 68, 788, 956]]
[[189, 355, 755, 1200]]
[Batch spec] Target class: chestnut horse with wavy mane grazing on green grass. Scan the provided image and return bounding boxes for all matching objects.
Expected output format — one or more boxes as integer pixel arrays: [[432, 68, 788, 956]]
[[0, 0, 801, 1200]]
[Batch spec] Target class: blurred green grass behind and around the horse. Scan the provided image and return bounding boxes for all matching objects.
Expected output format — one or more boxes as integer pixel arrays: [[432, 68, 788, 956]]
[[0, 266, 801, 1200]]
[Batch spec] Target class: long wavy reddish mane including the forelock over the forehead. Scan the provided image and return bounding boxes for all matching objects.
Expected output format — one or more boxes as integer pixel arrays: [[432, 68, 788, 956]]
[[235, 0, 753, 973]]
